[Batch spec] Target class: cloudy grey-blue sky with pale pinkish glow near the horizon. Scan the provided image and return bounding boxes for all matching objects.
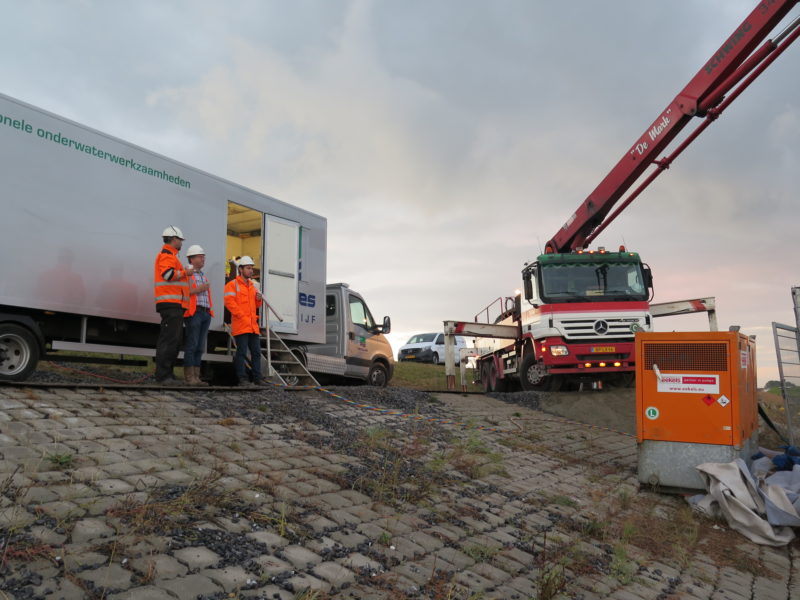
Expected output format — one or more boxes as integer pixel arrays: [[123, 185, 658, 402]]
[[0, 0, 800, 385]]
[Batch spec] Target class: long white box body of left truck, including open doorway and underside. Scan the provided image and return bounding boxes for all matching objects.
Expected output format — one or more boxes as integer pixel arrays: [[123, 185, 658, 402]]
[[0, 94, 392, 380]]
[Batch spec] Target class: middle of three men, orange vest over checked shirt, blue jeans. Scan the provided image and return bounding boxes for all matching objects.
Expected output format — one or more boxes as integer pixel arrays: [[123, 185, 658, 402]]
[[183, 244, 214, 385]]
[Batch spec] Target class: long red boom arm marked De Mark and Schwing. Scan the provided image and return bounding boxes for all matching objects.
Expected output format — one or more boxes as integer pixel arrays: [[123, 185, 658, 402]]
[[545, 0, 800, 252]]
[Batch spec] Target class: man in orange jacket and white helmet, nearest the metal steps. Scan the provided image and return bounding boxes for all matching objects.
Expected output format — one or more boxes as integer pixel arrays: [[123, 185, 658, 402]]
[[225, 256, 264, 386]]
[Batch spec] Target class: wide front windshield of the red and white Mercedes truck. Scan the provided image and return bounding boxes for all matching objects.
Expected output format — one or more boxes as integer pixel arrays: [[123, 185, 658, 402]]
[[540, 261, 648, 303]]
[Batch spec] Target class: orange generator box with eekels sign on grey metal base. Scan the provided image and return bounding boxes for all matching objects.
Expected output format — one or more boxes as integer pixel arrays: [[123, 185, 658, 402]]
[[636, 331, 758, 490]]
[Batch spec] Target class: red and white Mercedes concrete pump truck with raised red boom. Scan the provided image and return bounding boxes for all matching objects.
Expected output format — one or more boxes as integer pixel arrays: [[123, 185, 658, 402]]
[[445, 0, 800, 391]]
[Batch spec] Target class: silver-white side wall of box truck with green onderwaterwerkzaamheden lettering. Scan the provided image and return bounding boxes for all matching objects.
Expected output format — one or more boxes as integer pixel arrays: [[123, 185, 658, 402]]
[[0, 95, 327, 343]]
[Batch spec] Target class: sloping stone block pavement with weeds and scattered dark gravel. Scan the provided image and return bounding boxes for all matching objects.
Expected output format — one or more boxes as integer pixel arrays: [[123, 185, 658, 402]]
[[0, 387, 800, 600]]
